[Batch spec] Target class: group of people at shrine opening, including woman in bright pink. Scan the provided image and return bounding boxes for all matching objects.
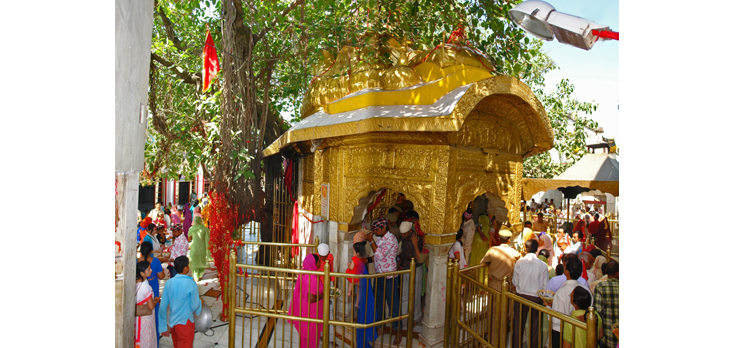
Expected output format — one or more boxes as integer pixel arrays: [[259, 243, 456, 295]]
[[289, 194, 429, 348]]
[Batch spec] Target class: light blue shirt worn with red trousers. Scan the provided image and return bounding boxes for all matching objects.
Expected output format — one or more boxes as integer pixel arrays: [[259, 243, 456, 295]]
[[158, 274, 202, 333]]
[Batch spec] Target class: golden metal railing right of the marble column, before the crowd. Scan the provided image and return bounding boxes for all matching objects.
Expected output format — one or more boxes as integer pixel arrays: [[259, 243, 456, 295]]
[[443, 259, 598, 348]]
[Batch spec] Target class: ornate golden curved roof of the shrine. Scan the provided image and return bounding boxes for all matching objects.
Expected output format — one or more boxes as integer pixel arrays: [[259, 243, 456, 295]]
[[264, 44, 553, 157]]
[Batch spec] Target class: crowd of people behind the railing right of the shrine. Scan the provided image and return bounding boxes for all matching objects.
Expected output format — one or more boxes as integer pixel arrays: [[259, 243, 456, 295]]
[[470, 204, 619, 348]]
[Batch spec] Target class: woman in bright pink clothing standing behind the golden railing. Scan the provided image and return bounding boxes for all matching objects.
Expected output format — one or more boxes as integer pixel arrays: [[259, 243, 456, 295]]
[[288, 254, 325, 348]]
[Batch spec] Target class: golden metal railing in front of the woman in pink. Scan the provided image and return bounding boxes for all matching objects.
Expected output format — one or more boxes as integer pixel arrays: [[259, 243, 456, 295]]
[[228, 249, 416, 348]]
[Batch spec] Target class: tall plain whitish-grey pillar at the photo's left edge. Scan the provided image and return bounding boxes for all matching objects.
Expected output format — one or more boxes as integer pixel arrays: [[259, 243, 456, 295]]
[[114, 0, 154, 348]]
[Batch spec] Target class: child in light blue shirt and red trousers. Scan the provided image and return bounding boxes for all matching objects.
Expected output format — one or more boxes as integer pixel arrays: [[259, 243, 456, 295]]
[[158, 256, 202, 347]]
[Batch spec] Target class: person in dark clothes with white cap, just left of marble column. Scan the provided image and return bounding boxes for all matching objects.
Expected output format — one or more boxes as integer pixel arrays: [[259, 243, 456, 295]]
[[398, 221, 424, 327]]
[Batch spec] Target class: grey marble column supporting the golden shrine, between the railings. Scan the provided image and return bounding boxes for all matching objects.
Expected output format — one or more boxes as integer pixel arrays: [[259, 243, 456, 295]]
[[422, 244, 452, 348]]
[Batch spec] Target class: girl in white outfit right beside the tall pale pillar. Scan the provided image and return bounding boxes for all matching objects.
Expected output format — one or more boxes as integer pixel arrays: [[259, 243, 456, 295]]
[[134, 261, 157, 348]]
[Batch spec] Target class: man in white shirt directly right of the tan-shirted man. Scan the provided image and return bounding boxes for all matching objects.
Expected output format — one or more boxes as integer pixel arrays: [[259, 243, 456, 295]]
[[511, 239, 548, 348]]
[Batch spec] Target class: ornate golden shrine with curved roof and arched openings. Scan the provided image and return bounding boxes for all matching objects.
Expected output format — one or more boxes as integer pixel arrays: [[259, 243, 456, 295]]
[[264, 40, 553, 346]]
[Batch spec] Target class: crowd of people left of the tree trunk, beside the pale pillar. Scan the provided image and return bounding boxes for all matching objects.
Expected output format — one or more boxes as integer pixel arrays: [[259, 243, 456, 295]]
[[134, 195, 210, 348]]
